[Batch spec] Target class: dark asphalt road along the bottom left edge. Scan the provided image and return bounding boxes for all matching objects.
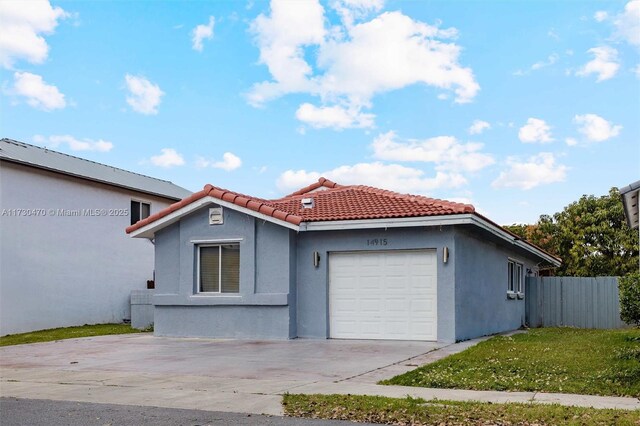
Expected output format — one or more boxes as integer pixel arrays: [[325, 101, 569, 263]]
[[0, 398, 376, 426]]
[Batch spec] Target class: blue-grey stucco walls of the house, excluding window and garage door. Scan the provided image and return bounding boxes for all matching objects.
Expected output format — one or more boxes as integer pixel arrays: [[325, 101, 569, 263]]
[[154, 202, 536, 342]]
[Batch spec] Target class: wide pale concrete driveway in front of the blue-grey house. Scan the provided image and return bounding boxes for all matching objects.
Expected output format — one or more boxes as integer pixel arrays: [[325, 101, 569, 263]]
[[0, 334, 445, 414]]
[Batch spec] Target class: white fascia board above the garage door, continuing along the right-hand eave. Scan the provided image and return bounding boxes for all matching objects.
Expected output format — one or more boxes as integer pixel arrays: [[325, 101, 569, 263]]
[[300, 213, 560, 266]]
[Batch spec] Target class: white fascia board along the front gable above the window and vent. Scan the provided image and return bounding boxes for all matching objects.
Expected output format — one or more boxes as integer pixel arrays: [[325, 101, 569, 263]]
[[129, 195, 300, 238]]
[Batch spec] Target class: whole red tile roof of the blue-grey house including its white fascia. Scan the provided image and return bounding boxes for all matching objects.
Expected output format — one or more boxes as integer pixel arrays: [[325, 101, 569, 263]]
[[126, 178, 560, 266]]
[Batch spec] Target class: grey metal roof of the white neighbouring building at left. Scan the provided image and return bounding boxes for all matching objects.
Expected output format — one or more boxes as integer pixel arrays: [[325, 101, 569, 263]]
[[0, 138, 191, 200]]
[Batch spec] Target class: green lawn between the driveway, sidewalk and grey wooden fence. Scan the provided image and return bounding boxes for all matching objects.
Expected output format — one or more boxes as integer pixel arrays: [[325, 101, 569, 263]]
[[380, 328, 640, 397]]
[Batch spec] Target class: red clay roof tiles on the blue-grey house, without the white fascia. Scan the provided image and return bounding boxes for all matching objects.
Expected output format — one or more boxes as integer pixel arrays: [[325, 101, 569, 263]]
[[127, 178, 475, 233]]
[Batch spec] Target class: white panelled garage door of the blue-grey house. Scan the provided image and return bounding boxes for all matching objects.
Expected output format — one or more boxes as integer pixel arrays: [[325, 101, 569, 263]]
[[329, 250, 437, 340]]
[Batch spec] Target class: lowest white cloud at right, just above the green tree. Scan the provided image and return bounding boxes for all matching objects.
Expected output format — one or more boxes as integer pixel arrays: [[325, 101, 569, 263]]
[[491, 152, 568, 190]]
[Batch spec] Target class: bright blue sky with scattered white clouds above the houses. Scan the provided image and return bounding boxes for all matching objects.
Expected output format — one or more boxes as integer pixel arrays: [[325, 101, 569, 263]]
[[0, 0, 640, 224]]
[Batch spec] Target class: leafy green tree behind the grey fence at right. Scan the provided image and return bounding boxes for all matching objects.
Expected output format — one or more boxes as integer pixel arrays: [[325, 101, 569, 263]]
[[507, 188, 638, 277]]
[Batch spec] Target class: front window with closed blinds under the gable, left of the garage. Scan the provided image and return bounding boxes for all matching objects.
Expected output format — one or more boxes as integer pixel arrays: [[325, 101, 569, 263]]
[[198, 243, 240, 293]]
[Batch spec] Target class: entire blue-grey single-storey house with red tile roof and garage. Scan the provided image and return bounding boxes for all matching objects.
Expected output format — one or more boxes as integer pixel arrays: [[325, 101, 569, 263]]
[[127, 178, 560, 342]]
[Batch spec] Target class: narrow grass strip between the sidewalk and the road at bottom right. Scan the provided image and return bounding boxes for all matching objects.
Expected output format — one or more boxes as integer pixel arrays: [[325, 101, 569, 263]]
[[282, 394, 640, 426]]
